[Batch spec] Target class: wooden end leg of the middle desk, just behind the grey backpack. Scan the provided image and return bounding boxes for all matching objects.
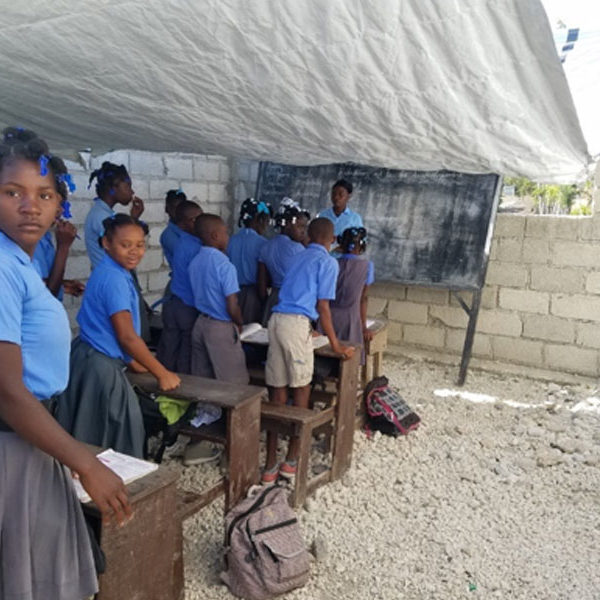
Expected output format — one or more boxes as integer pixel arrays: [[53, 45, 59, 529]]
[[225, 397, 260, 511]]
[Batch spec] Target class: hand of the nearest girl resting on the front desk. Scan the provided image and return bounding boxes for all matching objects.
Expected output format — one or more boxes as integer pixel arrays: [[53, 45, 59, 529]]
[[79, 459, 132, 525]]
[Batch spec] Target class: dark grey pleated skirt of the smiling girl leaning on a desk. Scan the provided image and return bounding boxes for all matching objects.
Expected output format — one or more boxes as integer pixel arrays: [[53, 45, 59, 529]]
[[56, 337, 145, 458]]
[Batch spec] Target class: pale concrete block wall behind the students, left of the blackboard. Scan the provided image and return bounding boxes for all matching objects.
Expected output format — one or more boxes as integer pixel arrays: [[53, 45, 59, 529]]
[[59, 150, 233, 328]]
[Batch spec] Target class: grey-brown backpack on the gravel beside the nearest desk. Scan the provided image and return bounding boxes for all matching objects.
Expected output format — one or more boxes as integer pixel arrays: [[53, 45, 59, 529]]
[[221, 486, 310, 600]]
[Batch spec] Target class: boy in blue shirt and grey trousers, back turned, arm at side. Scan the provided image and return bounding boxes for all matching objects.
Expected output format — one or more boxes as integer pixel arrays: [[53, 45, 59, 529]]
[[188, 213, 249, 383]]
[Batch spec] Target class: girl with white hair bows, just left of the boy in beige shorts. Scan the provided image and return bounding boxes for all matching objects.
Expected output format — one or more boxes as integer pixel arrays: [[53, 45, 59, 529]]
[[258, 198, 310, 327]]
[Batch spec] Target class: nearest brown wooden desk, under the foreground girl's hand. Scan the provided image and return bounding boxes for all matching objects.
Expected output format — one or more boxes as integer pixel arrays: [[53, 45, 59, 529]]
[[82, 466, 184, 600]]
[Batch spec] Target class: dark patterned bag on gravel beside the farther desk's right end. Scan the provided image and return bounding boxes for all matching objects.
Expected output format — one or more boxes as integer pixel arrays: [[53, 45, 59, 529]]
[[363, 376, 421, 436]]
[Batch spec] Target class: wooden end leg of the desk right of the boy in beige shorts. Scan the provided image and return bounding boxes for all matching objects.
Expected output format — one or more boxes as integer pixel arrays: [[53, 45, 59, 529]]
[[331, 352, 360, 481]]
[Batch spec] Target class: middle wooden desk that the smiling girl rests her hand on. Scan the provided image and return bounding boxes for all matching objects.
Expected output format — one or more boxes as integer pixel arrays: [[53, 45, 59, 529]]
[[127, 373, 266, 510]]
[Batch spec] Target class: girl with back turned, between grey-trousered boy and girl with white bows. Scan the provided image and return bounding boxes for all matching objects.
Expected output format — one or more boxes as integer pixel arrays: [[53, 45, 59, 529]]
[[227, 198, 271, 324]]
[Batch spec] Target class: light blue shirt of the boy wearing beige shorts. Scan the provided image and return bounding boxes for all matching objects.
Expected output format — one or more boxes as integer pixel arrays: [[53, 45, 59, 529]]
[[273, 244, 340, 321]]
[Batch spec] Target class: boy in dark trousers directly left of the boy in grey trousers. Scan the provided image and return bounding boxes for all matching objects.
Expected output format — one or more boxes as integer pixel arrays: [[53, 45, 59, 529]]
[[156, 200, 202, 373]]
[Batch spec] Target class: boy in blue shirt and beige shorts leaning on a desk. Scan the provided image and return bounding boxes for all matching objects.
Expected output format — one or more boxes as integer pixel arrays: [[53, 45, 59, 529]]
[[262, 217, 354, 483]]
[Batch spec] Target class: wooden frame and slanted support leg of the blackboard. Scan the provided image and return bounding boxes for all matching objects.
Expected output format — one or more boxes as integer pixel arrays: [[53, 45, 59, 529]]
[[255, 162, 502, 385]]
